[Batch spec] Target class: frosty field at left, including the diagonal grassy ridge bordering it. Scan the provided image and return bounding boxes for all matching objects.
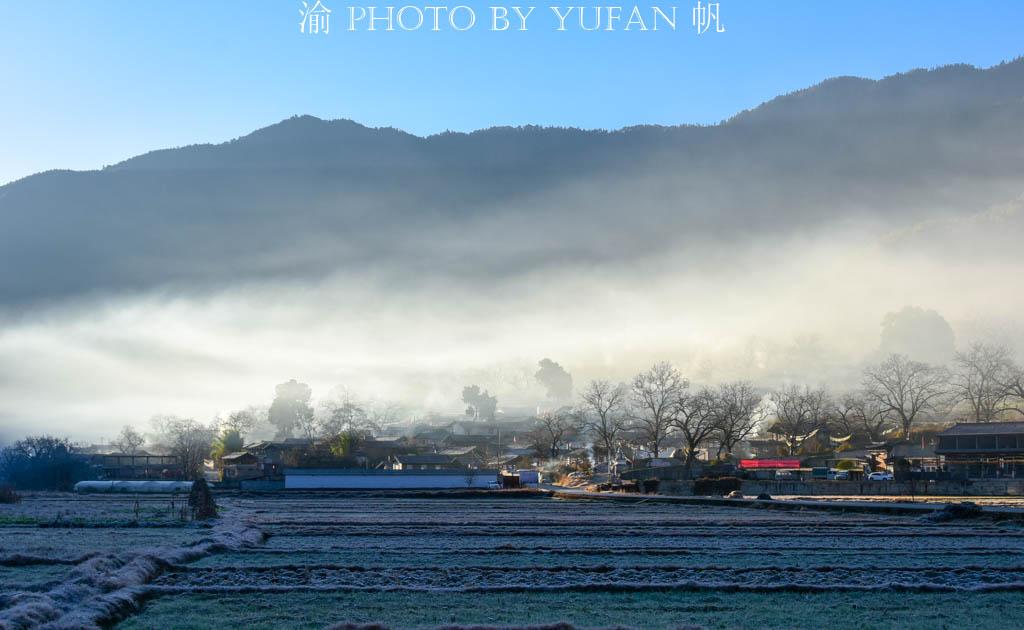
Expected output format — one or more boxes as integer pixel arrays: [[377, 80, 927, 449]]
[[0, 494, 263, 629]]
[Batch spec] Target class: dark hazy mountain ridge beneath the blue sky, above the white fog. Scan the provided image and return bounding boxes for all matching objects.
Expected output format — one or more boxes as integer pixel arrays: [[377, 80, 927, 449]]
[[0, 59, 1024, 307]]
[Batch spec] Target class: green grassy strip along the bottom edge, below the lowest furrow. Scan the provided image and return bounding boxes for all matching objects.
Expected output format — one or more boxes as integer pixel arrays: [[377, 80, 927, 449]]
[[121, 591, 1024, 630]]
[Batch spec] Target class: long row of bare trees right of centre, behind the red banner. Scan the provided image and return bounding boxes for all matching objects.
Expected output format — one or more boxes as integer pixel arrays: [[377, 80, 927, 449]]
[[532, 343, 1024, 468]]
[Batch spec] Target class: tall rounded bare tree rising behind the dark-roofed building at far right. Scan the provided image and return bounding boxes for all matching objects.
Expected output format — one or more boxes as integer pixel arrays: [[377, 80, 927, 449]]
[[949, 343, 1015, 422]]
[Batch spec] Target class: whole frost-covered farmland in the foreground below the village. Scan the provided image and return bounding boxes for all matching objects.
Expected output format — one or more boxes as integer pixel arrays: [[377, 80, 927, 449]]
[[0, 493, 1024, 628]]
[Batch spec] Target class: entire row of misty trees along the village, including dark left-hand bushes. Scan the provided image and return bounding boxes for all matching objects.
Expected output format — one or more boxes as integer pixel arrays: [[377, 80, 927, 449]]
[[8, 343, 1024, 488]]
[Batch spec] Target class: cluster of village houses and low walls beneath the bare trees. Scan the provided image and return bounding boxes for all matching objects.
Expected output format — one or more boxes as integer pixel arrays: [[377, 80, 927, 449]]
[[81, 417, 1024, 489]]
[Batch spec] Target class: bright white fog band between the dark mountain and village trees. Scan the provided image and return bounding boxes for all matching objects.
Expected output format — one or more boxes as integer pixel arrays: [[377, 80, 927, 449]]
[[0, 198, 1024, 440]]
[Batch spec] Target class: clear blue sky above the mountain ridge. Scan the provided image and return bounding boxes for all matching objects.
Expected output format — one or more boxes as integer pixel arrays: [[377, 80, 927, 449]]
[[0, 0, 1024, 182]]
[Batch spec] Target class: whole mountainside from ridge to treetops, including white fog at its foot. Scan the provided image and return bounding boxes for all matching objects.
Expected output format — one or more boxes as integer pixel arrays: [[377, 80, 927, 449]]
[[6, 59, 1024, 439]]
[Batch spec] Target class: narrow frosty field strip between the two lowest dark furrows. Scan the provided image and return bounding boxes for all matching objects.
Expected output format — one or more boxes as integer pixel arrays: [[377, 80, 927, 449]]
[[152, 565, 1024, 593]]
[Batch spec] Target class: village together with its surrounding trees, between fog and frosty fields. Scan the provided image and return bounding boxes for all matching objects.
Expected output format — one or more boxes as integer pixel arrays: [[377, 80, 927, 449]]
[[39, 345, 1024, 496]]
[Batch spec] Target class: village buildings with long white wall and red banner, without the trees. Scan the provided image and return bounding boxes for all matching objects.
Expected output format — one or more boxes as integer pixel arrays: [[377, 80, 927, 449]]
[[70, 418, 1024, 496]]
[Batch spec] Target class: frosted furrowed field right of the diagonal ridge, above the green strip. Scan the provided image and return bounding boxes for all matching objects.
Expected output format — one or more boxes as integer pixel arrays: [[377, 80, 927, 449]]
[[150, 495, 1024, 596]]
